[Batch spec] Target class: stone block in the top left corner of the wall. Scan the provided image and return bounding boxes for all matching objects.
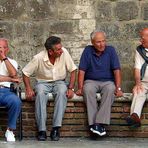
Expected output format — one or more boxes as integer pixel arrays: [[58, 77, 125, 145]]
[[0, 0, 25, 20]]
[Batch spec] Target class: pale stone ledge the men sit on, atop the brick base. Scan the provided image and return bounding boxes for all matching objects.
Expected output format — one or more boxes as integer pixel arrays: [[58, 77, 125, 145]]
[[22, 92, 136, 102]]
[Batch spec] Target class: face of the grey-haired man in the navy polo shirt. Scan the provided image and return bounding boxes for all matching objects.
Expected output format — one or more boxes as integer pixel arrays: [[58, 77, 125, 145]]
[[91, 32, 106, 52]]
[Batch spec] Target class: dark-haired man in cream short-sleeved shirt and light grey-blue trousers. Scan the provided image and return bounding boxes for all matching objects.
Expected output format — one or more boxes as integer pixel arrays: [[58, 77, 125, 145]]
[[23, 36, 77, 141]]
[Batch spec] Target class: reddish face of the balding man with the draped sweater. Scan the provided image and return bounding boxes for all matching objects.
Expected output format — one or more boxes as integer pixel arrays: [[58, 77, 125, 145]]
[[141, 28, 148, 48]]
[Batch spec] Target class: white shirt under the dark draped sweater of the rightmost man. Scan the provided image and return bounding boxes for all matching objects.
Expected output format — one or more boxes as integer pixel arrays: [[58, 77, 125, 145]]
[[135, 48, 148, 82]]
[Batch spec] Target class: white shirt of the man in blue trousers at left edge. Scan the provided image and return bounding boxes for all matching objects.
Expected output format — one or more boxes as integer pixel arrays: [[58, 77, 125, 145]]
[[0, 58, 18, 87]]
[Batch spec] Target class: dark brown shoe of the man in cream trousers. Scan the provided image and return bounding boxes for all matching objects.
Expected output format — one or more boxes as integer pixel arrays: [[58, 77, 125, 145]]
[[126, 113, 141, 128]]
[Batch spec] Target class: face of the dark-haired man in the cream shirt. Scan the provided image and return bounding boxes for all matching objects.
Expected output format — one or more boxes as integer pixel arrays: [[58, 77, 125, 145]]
[[49, 44, 63, 57]]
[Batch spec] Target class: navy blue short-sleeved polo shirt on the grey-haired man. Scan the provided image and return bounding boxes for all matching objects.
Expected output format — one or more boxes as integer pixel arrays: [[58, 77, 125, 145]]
[[79, 45, 120, 81]]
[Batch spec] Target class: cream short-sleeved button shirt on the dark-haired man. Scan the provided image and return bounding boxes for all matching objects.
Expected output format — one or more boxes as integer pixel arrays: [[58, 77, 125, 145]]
[[22, 47, 77, 82]]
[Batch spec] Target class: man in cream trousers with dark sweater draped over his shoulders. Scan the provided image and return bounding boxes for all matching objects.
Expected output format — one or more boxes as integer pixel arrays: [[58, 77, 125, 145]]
[[126, 28, 148, 127]]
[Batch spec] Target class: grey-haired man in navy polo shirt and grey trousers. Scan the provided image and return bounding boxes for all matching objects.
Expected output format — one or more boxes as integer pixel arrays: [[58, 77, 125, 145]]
[[76, 30, 123, 136]]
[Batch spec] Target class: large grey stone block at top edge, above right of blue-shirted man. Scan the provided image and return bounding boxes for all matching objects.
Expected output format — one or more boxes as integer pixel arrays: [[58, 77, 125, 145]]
[[114, 1, 139, 21]]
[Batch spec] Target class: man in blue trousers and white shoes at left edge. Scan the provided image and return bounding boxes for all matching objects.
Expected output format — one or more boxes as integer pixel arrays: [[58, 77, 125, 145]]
[[0, 38, 21, 141]]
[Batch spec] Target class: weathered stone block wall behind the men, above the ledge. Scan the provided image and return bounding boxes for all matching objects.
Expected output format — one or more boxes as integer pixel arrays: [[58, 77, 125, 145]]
[[0, 0, 148, 92]]
